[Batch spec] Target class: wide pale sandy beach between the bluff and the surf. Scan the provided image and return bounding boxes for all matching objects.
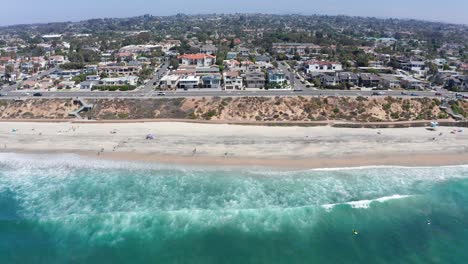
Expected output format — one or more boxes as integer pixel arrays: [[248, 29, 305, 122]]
[[0, 122, 468, 168]]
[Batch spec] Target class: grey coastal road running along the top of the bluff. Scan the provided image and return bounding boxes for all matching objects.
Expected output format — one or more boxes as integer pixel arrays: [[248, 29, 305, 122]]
[[0, 89, 462, 99]]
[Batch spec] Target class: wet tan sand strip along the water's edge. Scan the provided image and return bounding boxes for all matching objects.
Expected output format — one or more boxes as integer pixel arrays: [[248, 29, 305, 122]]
[[0, 149, 468, 170]]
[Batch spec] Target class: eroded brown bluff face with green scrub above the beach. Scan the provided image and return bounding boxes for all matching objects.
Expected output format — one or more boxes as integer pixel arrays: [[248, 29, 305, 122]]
[[0, 96, 458, 122]]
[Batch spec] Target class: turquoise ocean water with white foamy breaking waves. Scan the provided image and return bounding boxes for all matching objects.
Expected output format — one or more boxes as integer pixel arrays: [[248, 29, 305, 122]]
[[0, 154, 468, 263]]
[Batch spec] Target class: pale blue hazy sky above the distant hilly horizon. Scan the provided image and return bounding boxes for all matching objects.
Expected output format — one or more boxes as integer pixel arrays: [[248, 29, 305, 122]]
[[0, 0, 468, 26]]
